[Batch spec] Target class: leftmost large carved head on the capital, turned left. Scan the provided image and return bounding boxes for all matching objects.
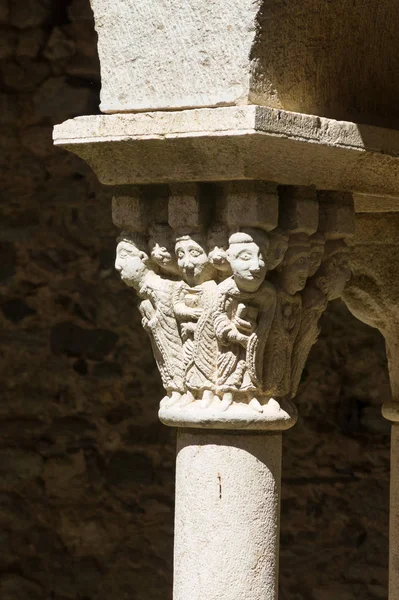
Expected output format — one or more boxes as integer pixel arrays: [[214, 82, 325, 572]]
[[115, 232, 149, 288]]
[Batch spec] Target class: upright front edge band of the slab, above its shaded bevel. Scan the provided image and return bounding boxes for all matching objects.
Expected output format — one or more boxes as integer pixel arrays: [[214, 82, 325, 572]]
[[53, 106, 399, 158]]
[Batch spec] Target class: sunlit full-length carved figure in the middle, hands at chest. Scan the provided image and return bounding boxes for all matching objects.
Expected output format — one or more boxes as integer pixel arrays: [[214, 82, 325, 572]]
[[173, 234, 217, 402]]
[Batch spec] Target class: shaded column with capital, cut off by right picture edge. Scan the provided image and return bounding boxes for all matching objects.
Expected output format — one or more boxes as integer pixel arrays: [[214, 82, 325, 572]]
[[344, 214, 399, 600]]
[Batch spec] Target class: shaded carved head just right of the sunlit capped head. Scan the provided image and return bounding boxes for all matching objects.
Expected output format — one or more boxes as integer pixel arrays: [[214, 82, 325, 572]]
[[277, 233, 310, 296]]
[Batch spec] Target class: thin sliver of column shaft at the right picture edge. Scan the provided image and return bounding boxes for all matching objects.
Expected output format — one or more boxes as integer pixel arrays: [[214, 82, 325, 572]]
[[389, 423, 399, 600]]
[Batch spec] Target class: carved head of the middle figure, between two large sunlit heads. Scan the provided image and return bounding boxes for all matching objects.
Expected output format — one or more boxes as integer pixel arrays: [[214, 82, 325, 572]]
[[175, 234, 215, 286]]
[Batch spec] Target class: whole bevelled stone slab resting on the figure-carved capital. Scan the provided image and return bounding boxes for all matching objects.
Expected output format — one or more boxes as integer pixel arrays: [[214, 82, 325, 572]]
[[54, 106, 399, 202]]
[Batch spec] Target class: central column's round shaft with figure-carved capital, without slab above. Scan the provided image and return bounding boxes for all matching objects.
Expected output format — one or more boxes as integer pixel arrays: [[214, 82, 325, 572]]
[[108, 181, 353, 600]]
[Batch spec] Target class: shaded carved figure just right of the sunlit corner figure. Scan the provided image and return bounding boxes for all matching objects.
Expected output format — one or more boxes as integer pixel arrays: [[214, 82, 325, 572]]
[[264, 233, 310, 398]]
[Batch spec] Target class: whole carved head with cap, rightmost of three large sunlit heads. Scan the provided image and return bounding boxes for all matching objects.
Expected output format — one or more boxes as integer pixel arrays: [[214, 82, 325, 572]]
[[227, 228, 269, 292]]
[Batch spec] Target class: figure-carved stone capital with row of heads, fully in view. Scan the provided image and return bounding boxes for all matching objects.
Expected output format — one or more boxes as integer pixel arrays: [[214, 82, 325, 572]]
[[113, 181, 353, 430]]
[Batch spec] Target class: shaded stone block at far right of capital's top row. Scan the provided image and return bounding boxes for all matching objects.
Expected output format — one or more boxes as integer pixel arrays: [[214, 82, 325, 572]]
[[318, 191, 355, 240]]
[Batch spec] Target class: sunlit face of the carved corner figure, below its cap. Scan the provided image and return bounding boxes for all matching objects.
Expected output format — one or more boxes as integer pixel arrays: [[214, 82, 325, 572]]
[[227, 241, 267, 292]]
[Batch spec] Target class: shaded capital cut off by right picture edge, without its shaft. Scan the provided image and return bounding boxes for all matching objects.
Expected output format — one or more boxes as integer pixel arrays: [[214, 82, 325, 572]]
[[344, 213, 399, 421]]
